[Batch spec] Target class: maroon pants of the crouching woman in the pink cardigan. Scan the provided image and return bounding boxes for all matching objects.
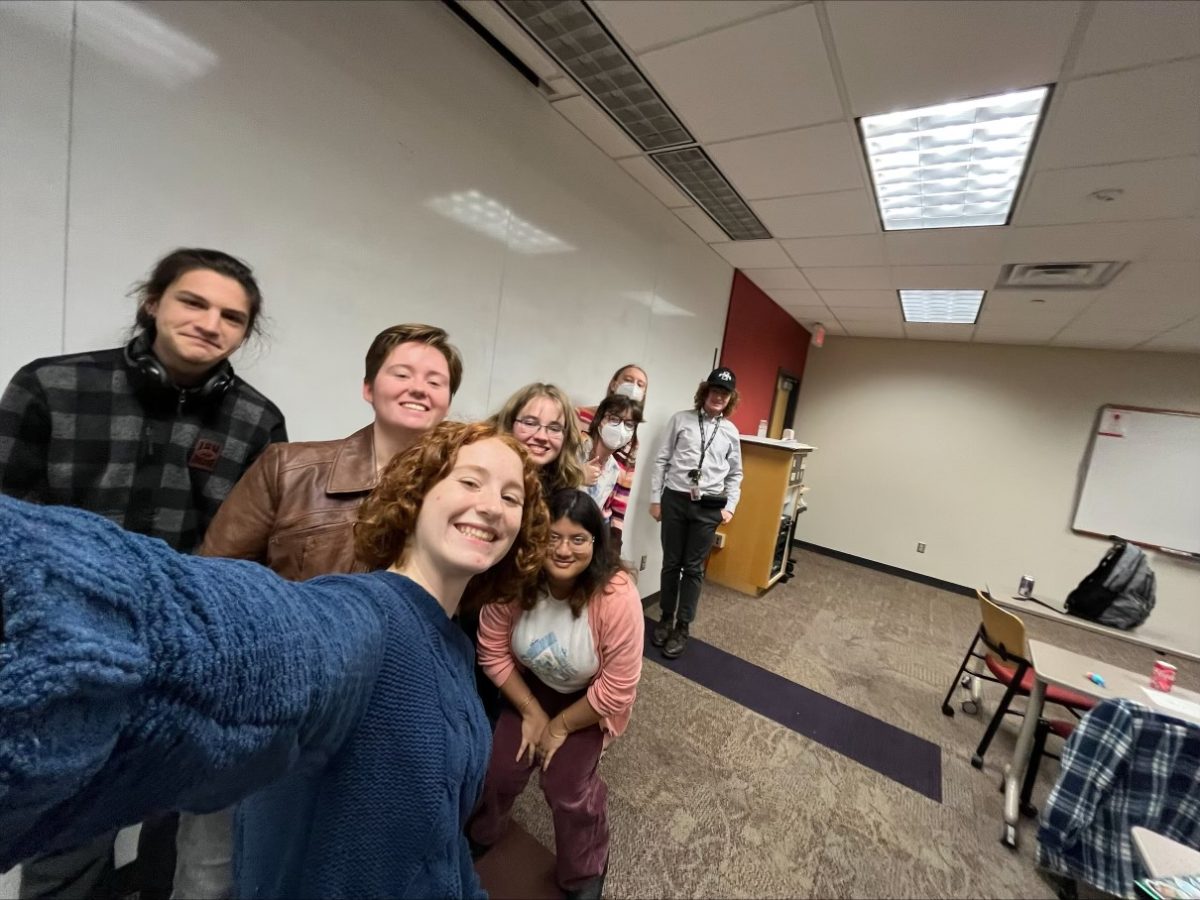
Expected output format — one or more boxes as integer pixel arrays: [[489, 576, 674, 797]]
[[467, 674, 608, 890]]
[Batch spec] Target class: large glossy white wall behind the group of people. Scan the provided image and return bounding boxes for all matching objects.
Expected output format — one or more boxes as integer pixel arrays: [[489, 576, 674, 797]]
[[0, 2, 732, 593]]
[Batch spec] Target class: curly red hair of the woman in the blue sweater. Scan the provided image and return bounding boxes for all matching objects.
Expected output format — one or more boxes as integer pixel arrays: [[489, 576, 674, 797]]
[[354, 421, 550, 610]]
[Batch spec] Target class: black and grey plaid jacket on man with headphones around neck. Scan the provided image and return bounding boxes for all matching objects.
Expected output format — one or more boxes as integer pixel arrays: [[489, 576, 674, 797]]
[[0, 348, 287, 553]]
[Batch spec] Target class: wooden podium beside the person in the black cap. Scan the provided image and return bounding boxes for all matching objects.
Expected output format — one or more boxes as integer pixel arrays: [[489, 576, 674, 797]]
[[708, 434, 816, 596]]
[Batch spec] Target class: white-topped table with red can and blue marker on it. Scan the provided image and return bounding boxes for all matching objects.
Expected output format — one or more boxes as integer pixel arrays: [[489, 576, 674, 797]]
[[1001, 641, 1200, 847]]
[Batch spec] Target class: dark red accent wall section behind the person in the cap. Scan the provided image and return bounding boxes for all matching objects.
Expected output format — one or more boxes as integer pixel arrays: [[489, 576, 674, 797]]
[[721, 271, 812, 434]]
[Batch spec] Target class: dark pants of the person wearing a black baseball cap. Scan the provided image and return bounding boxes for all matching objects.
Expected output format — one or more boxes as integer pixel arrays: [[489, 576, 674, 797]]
[[659, 491, 721, 624]]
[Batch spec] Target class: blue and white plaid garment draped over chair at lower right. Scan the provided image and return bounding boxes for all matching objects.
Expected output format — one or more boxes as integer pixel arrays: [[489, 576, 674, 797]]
[[1038, 700, 1200, 898]]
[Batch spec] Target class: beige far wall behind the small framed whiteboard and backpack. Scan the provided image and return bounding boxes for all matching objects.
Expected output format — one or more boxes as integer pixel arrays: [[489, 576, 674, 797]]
[[794, 337, 1200, 653]]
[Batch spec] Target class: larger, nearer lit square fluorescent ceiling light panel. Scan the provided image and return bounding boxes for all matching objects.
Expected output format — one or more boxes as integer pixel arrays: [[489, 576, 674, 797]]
[[858, 86, 1050, 232]]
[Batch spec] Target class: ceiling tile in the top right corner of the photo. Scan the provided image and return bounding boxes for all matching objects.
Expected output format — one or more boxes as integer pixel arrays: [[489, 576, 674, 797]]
[[1072, 0, 1200, 76]]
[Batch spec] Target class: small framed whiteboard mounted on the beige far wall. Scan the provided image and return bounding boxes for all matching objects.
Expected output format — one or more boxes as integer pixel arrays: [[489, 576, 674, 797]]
[[1072, 406, 1200, 553]]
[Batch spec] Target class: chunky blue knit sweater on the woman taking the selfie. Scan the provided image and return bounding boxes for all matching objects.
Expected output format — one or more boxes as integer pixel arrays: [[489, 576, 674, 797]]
[[0, 497, 491, 898]]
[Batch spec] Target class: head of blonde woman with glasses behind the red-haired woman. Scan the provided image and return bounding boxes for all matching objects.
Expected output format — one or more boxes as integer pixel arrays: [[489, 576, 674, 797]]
[[490, 382, 583, 496]]
